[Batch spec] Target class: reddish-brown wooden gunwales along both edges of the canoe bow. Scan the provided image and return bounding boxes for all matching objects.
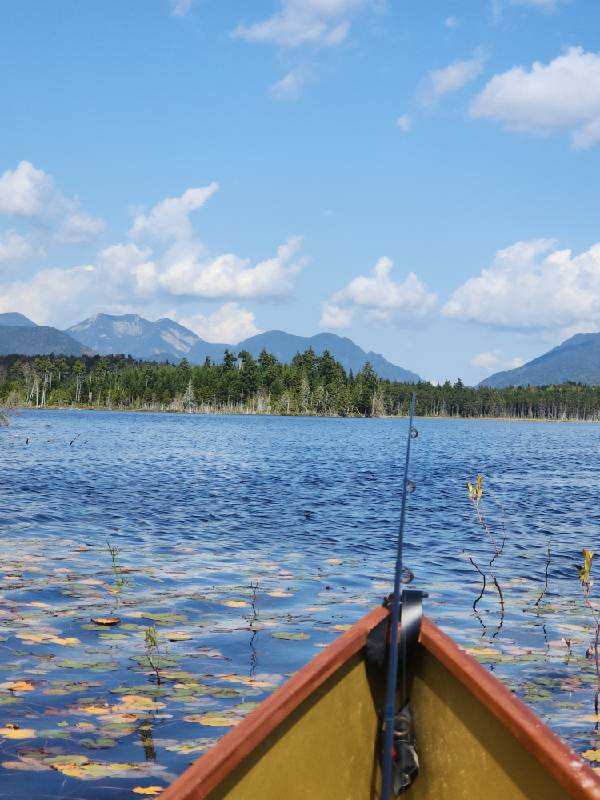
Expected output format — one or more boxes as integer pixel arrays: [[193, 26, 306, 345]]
[[160, 607, 600, 800]]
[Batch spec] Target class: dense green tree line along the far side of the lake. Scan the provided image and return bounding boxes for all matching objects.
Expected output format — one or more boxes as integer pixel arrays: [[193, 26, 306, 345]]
[[0, 349, 600, 420]]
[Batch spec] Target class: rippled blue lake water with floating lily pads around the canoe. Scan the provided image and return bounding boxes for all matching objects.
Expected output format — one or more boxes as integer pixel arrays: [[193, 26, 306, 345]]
[[0, 411, 600, 799]]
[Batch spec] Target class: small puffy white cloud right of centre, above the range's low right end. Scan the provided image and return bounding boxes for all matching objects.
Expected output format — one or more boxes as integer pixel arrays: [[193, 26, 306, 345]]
[[321, 257, 437, 327]]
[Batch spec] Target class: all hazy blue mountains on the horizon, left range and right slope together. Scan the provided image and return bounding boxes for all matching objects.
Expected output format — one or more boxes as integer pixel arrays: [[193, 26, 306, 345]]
[[5, 312, 600, 388]]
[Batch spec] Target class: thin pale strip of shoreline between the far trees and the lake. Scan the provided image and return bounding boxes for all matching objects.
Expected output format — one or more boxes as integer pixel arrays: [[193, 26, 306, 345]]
[[0, 405, 600, 427]]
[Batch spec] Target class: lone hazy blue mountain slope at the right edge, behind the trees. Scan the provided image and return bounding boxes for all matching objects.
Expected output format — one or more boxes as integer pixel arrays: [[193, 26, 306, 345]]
[[479, 333, 600, 388]]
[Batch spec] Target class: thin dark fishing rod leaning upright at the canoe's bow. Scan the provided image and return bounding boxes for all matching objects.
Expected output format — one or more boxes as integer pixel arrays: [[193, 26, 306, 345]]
[[381, 394, 419, 800]]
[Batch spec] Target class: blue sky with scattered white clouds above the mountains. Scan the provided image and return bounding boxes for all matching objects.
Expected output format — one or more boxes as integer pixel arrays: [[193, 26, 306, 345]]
[[0, 0, 600, 382]]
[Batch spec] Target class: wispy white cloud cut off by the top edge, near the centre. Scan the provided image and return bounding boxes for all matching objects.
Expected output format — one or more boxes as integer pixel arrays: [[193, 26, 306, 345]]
[[233, 0, 371, 47]]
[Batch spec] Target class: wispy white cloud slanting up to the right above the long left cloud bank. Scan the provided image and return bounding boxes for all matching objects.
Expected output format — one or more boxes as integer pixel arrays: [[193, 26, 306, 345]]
[[130, 181, 219, 240]]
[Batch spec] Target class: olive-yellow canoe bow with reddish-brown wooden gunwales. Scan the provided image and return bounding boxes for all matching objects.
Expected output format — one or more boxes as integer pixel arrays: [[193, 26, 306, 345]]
[[161, 608, 600, 800]]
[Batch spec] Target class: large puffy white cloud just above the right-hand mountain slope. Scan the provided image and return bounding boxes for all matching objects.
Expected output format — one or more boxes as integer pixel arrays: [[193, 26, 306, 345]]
[[443, 239, 600, 338]]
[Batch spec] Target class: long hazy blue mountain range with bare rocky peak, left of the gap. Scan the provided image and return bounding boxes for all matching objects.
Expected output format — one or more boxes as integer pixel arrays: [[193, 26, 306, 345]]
[[0, 314, 420, 383]]
